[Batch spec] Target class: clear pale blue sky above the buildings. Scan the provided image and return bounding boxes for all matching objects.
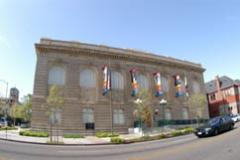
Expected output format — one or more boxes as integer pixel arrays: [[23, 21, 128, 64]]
[[0, 0, 240, 99]]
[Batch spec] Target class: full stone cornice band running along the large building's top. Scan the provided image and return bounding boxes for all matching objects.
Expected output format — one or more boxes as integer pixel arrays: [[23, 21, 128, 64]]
[[35, 39, 205, 72]]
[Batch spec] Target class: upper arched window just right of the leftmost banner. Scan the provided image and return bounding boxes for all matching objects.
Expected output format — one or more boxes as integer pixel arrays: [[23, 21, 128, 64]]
[[111, 71, 124, 89]]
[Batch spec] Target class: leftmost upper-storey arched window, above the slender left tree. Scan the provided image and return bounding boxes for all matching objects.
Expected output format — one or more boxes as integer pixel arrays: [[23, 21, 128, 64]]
[[48, 66, 65, 85]]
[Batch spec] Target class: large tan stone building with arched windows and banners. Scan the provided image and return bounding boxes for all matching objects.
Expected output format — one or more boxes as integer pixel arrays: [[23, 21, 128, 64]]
[[32, 39, 208, 134]]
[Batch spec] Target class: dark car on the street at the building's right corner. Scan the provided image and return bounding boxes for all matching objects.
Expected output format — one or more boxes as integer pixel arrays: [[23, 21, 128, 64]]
[[195, 115, 234, 137]]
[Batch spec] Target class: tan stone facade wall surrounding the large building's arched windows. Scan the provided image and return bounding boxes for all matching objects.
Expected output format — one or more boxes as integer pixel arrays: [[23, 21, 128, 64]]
[[32, 40, 208, 134]]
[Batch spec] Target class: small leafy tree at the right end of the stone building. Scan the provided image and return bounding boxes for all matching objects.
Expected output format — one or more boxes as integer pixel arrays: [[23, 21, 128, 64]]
[[186, 93, 207, 124]]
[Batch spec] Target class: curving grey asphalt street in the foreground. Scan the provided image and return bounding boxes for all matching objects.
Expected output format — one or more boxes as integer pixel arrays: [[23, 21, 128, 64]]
[[0, 124, 240, 160]]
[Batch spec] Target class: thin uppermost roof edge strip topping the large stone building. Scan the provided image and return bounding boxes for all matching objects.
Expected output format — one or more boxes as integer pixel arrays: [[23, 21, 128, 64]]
[[35, 38, 205, 71]]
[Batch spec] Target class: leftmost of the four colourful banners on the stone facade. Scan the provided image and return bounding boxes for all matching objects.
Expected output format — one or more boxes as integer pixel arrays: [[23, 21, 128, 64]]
[[102, 65, 111, 96]]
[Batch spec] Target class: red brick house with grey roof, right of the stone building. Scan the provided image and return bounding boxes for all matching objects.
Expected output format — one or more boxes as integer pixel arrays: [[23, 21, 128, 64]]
[[205, 76, 240, 117]]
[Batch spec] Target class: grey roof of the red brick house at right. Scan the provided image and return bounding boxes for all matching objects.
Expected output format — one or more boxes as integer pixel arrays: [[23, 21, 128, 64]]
[[205, 76, 240, 93]]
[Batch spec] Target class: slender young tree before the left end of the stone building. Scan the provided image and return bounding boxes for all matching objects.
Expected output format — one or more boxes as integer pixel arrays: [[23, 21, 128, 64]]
[[43, 85, 64, 142]]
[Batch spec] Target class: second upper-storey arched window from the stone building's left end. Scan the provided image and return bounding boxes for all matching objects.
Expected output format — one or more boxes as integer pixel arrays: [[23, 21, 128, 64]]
[[80, 69, 96, 87]]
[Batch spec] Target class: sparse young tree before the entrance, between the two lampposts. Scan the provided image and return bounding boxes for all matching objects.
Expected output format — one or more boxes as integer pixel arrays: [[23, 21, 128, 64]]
[[134, 89, 152, 127]]
